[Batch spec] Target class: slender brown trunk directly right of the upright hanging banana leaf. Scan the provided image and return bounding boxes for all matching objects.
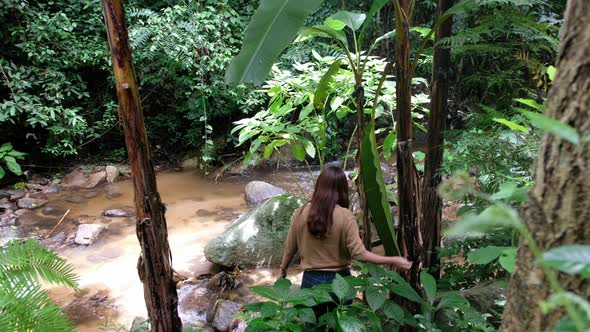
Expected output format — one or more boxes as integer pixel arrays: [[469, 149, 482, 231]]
[[395, 0, 422, 324]]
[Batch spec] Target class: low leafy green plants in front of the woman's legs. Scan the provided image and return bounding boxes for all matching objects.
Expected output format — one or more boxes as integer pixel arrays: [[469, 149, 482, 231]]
[[243, 263, 498, 331]]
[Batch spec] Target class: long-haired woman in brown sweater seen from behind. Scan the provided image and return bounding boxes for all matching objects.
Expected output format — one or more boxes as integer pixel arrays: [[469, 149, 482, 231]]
[[281, 167, 412, 318]]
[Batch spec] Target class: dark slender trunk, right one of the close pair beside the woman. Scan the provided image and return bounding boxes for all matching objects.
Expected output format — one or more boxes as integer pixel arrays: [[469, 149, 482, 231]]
[[422, 0, 454, 279]]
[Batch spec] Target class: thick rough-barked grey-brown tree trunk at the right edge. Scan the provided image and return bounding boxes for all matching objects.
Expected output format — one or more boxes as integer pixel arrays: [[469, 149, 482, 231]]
[[501, 0, 590, 332]]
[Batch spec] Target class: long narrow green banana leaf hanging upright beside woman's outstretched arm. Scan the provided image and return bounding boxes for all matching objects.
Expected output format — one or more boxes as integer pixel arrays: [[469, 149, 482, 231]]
[[361, 124, 400, 256]]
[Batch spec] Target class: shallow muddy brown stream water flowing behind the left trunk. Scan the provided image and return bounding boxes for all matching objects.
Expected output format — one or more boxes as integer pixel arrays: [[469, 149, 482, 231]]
[[13, 171, 311, 332]]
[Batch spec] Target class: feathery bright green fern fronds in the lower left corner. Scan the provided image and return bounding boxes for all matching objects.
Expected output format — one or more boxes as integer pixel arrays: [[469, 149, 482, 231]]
[[0, 240, 77, 331]]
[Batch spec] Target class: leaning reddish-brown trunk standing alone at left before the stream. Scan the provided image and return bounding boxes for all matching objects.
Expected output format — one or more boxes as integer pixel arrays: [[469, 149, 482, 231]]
[[103, 0, 182, 332]]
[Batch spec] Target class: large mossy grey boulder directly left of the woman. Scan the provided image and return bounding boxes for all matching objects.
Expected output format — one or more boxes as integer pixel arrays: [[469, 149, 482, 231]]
[[205, 196, 306, 267]]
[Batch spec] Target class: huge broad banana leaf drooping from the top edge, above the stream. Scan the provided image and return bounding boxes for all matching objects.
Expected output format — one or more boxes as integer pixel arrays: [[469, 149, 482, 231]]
[[225, 0, 323, 84]]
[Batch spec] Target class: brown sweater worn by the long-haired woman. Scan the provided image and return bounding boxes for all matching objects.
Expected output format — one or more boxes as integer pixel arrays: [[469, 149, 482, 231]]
[[281, 205, 366, 271]]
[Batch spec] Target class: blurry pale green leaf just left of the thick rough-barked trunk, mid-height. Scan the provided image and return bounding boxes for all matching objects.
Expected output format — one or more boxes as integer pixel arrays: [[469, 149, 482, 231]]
[[445, 205, 522, 237]]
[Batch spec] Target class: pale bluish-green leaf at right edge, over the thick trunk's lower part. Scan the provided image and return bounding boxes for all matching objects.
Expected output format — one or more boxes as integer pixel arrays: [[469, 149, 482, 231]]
[[543, 244, 590, 278]]
